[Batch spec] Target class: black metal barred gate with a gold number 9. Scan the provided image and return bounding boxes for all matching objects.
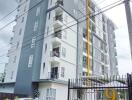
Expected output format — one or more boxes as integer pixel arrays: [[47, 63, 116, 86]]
[[68, 74, 132, 100]]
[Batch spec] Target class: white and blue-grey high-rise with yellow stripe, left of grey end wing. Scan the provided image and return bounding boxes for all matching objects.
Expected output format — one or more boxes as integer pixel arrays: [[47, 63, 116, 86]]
[[0, 0, 117, 100]]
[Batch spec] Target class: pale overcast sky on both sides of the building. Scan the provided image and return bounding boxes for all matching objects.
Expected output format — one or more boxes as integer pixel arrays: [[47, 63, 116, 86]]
[[0, 0, 132, 74]]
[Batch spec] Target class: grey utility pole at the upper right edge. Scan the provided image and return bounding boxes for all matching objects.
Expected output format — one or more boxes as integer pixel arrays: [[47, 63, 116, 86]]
[[124, 0, 132, 58]]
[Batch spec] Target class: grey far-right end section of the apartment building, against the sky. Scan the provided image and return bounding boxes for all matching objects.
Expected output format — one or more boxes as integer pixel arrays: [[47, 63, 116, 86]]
[[107, 20, 119, 76]]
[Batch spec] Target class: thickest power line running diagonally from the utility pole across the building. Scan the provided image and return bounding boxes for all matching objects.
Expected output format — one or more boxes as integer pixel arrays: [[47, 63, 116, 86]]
[[0, 2, 124, 57]]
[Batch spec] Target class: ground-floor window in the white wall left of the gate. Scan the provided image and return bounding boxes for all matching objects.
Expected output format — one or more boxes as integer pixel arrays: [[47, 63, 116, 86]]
[[46, 88, 56, 100]]
